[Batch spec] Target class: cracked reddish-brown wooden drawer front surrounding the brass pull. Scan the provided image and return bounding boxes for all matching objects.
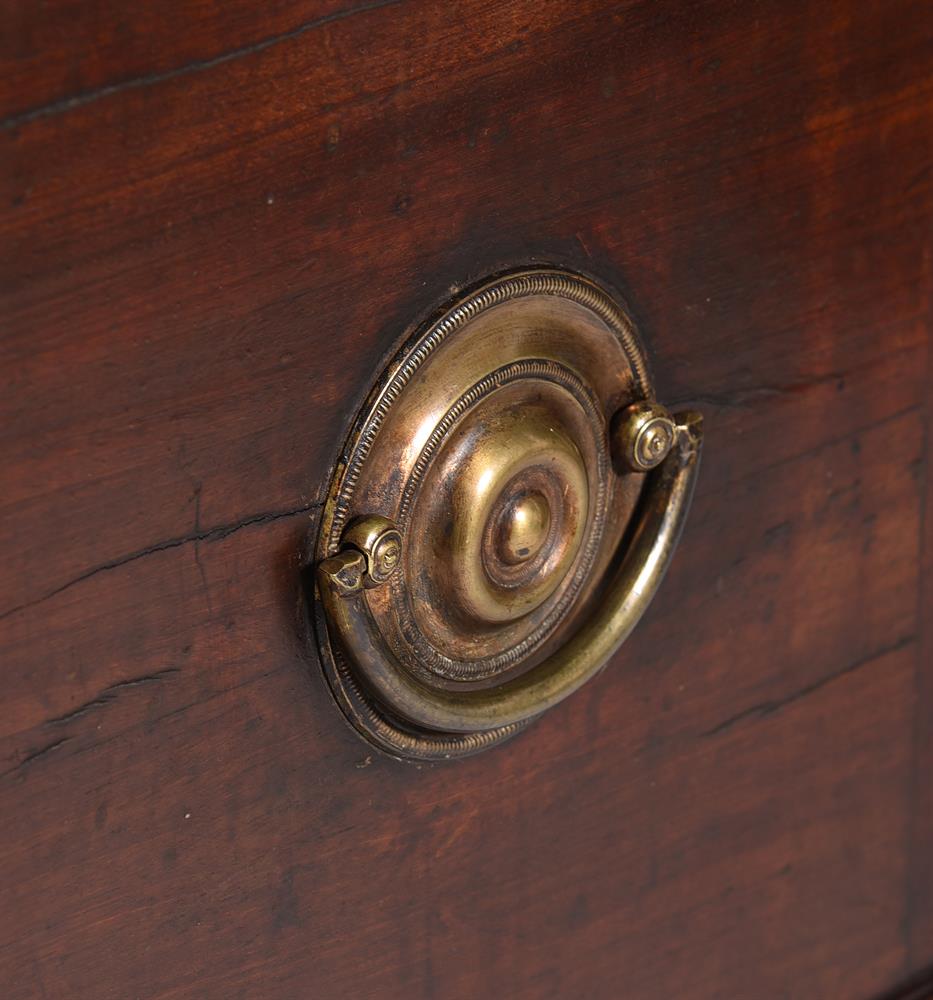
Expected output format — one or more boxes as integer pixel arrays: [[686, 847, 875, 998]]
[[0, 0, 933, 1000]]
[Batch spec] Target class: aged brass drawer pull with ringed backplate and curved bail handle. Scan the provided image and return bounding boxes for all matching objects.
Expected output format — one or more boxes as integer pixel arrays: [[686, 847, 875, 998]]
[[315, 268, 700, 758]]
